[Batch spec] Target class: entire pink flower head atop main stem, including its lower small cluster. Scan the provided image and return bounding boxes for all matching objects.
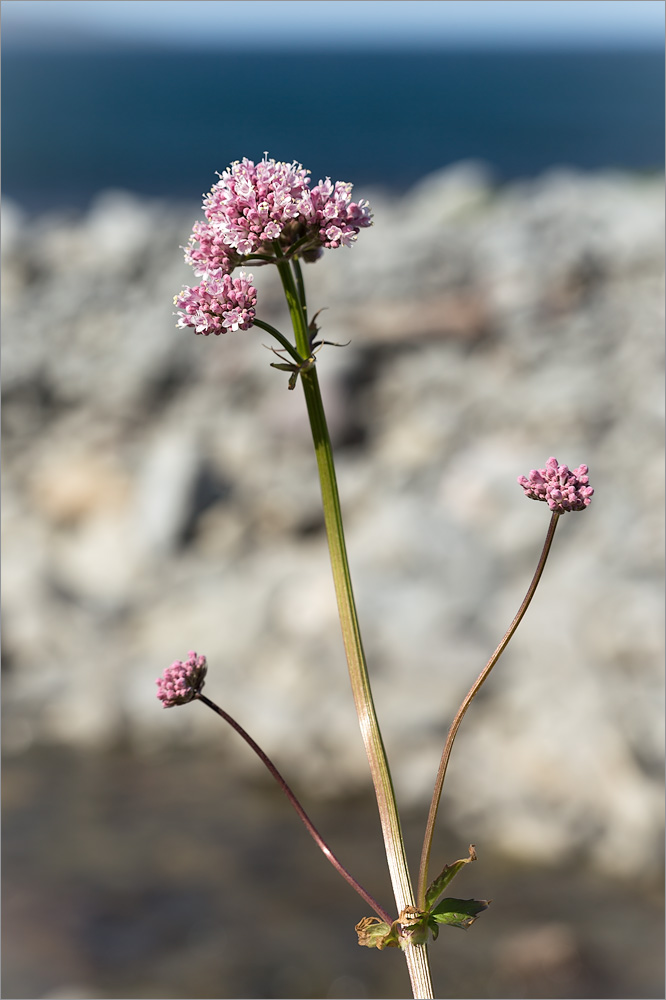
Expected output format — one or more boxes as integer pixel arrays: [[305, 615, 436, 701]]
[[174, 155, 372, 335]]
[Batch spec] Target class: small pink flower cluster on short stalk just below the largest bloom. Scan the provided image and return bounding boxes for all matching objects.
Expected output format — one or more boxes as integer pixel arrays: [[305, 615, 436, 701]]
[[173, 271, 257, 337]]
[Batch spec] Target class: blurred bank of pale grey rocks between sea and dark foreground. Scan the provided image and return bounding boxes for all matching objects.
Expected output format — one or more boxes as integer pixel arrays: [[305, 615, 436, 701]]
[[3, 164, 663, 874]]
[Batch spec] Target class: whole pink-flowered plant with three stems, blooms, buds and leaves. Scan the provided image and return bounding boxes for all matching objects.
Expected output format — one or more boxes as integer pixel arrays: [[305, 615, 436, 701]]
[[157, 155, 594, 997]]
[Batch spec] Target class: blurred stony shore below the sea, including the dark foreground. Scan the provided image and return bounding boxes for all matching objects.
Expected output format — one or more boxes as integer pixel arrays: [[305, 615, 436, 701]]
[[3, 163, 664, 997]]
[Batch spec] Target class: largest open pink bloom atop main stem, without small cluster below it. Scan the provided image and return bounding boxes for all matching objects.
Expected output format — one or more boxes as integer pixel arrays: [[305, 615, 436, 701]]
[[185, 155, 372, 277]]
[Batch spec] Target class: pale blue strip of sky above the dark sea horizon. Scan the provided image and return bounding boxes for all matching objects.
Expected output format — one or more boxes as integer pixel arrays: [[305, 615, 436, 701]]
[[2, 0, 664, 49]]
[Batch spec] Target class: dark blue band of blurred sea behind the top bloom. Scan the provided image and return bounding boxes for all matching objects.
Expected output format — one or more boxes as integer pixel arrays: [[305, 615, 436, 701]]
[[2, 48, 664, 210]]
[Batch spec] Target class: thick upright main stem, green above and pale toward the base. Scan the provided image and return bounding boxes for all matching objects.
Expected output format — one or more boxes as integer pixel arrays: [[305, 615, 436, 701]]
[[278, 261, 433, 1000]]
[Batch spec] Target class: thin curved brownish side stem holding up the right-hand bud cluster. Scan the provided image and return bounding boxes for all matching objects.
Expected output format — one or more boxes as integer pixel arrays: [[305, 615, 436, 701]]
[[417, 514, 560, 909]]
